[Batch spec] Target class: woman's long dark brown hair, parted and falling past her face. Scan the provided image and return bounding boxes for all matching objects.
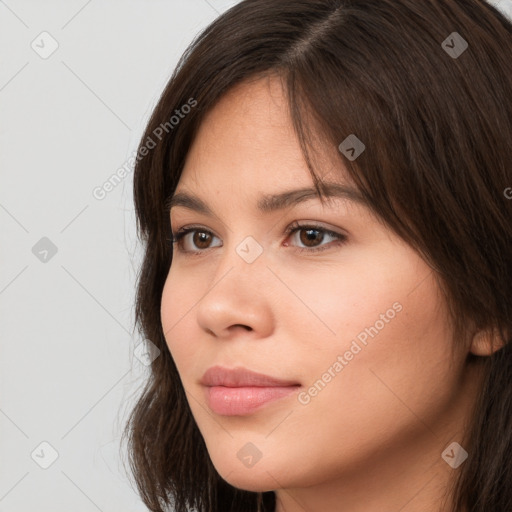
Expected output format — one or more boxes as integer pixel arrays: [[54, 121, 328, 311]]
[[123, 0, 512, 512]]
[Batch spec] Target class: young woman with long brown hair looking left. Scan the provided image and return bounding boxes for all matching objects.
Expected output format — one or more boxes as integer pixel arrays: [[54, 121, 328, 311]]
[[126, 0, 512, 512]]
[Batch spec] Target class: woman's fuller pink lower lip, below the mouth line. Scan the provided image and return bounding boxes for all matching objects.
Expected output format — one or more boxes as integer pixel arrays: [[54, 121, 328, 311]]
[[205, 386, 300, 416]]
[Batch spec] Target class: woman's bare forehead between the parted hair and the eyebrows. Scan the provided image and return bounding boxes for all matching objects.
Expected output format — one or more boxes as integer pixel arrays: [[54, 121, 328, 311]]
[[178, 76, 350, 194]]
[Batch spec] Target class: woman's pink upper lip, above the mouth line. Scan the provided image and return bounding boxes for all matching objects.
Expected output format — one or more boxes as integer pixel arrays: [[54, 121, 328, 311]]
[[201, 366, 300, 388]]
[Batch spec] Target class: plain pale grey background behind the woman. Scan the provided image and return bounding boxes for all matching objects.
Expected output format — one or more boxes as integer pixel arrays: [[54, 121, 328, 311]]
[[0, 0, 512, 512]]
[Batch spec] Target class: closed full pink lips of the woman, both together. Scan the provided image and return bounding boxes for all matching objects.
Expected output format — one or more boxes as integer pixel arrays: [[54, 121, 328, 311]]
[[201, 366, 300, 416]]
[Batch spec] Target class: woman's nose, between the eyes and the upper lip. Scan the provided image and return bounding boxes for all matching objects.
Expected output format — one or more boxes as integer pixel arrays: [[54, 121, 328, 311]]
[[196, 245, 275, 339]]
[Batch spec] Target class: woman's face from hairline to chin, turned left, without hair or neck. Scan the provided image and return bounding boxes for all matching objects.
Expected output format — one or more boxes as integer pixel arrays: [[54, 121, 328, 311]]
[[161, 78, 478, 504]]
